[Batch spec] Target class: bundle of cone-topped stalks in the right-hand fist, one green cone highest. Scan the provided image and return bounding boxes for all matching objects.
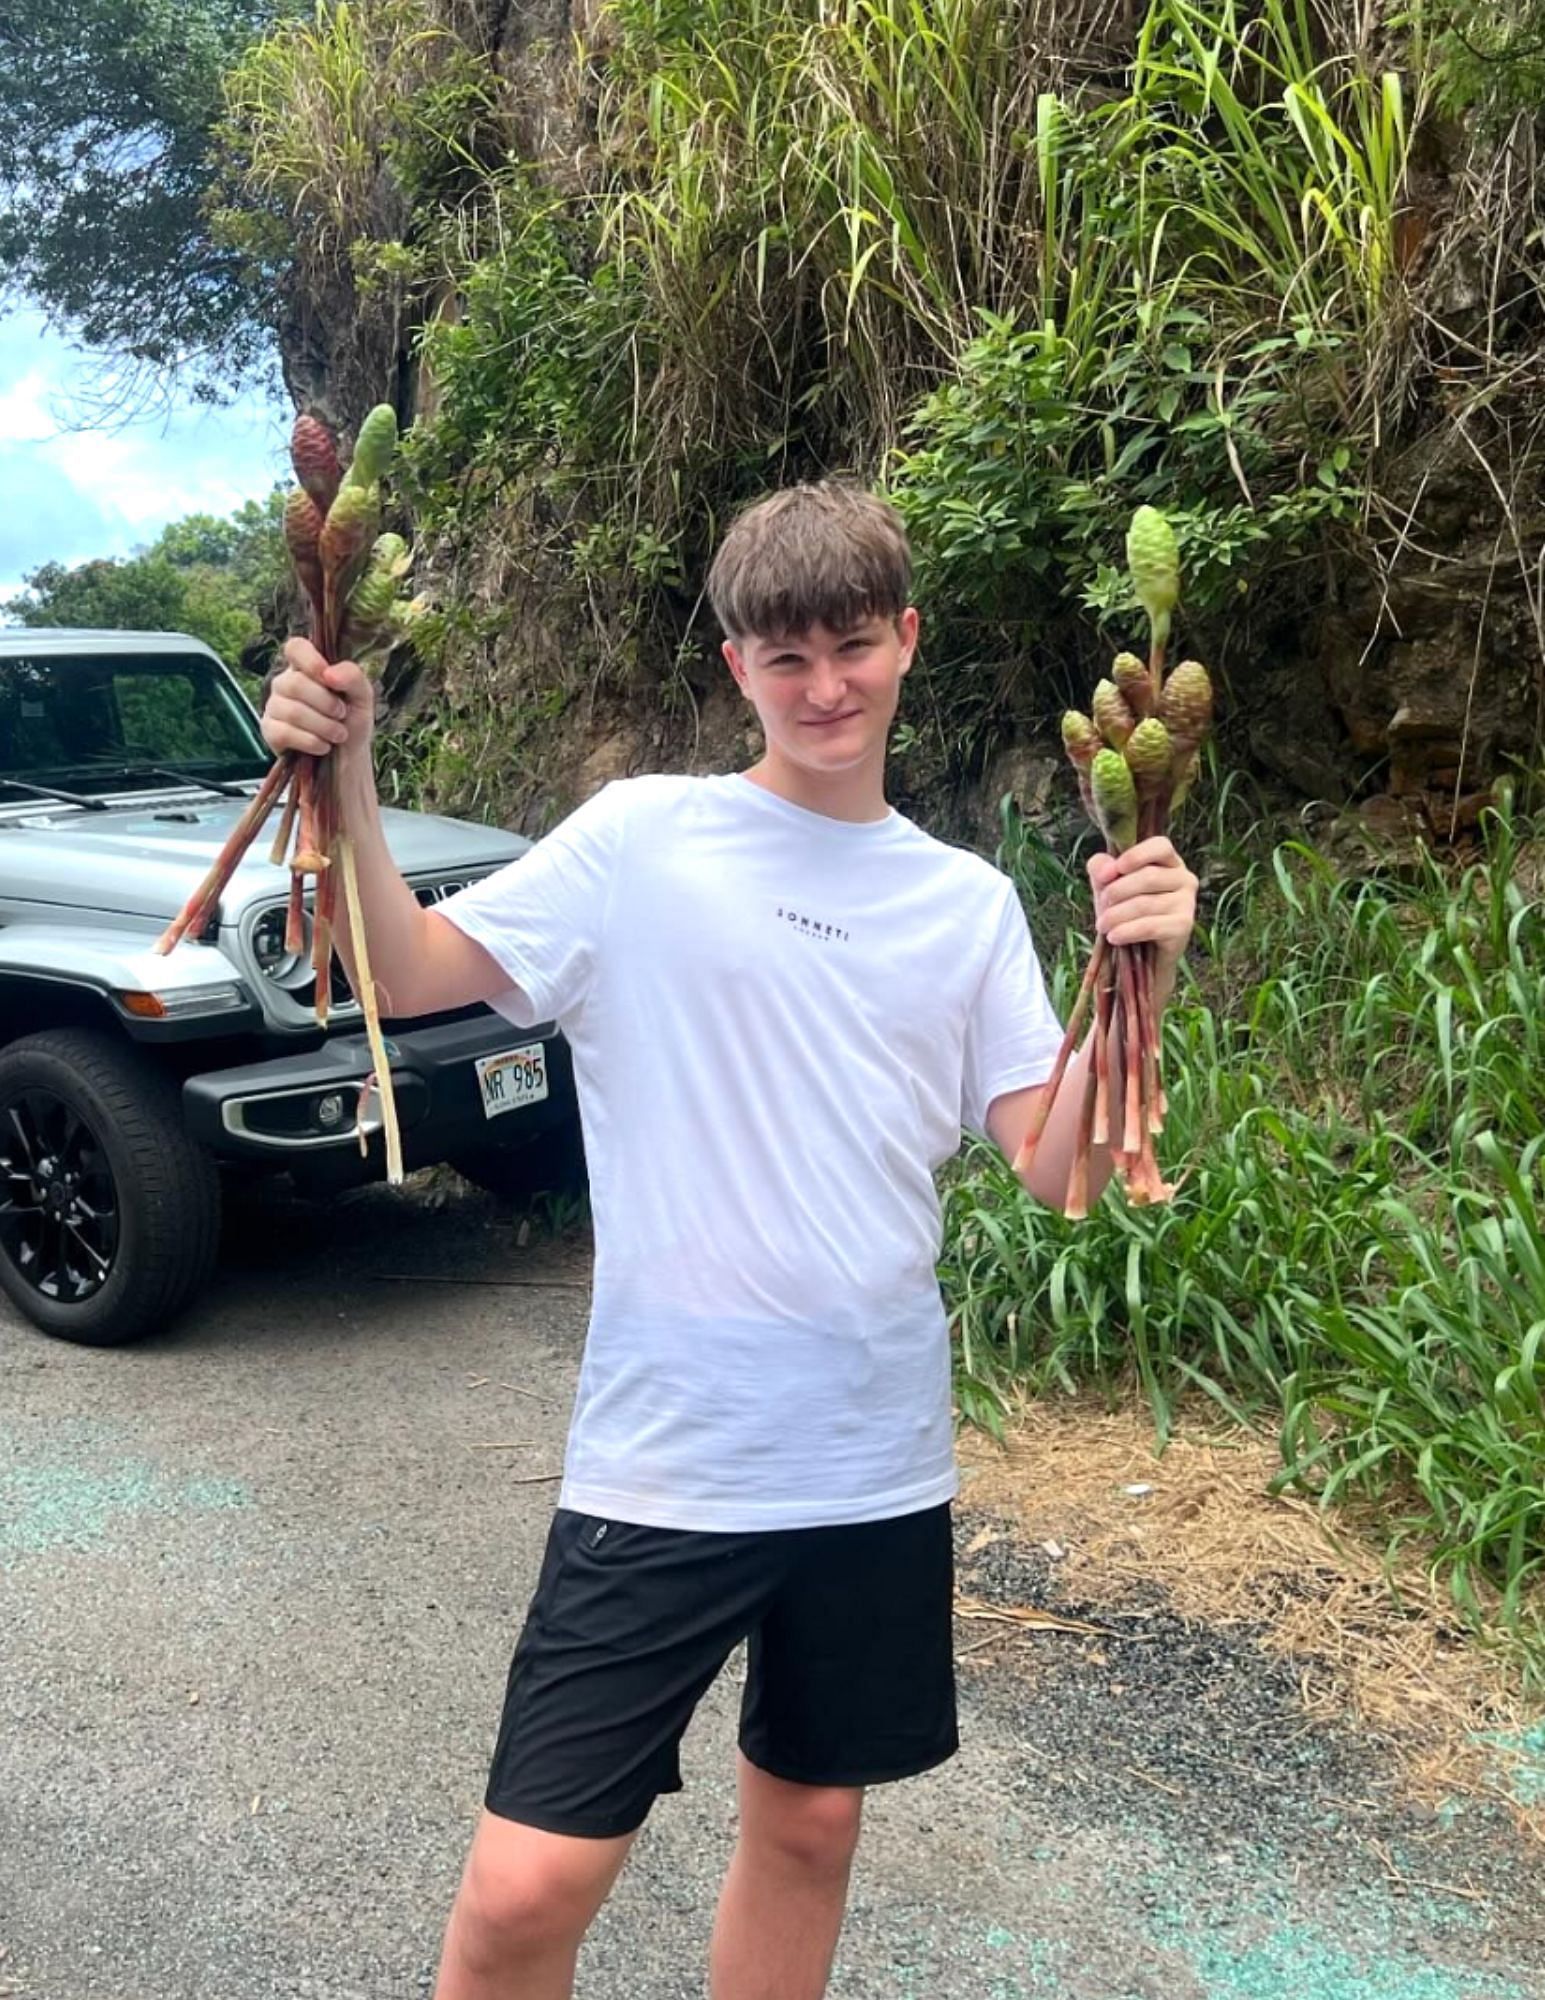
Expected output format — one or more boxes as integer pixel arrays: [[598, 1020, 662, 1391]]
[[1015, 506, 1213, 1218]]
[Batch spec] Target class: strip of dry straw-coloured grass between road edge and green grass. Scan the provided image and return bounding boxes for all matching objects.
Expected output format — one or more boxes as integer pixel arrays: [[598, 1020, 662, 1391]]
[[963, 1402, 1545, 1840]]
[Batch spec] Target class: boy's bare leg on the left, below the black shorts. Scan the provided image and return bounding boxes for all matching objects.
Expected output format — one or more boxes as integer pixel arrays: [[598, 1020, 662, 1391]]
[[434, 1812, 632, 2000]]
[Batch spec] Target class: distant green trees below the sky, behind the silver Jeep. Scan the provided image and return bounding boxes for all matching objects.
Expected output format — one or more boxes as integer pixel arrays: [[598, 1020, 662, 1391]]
[[4, 488, 288, 666]]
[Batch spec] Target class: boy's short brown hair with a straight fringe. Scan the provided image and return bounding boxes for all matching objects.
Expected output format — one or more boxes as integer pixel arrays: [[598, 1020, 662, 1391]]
[[708, 480, 913, 638]]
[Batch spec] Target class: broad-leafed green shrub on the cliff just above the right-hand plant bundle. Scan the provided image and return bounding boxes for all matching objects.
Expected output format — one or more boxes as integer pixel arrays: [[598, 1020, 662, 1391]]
[[891, 302, 1357, 628]]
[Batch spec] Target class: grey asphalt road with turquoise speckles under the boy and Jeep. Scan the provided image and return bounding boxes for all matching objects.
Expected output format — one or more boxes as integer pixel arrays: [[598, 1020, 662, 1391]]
[[0, 1192, 1545, 2000]]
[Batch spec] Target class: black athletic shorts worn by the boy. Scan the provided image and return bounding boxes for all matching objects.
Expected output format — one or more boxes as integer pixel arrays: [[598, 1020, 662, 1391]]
[[486, 1506, 959, 1838]]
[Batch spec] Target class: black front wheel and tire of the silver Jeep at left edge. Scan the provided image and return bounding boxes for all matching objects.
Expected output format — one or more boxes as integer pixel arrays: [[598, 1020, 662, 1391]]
[[0, 1028, 220, 1348]]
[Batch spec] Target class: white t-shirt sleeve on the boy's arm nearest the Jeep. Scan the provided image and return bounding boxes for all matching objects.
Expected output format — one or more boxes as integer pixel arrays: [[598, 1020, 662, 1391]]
[[434, 780, 628, 1028]]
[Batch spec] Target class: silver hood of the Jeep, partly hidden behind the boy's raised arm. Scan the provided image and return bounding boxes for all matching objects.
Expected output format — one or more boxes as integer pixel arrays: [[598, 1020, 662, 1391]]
[[0, 794, 530, 922]]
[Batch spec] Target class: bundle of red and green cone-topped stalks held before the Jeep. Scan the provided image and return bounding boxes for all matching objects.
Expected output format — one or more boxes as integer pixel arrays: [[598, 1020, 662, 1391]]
[[156, 404, 418, 1184]]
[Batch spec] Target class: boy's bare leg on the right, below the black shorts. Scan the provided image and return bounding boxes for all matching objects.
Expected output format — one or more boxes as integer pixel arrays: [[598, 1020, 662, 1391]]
[[708, 1758, 865, 2000]]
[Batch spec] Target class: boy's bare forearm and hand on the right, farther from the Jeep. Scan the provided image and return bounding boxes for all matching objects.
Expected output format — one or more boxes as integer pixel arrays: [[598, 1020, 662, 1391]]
[[987, 834, 1197, 1210]]
